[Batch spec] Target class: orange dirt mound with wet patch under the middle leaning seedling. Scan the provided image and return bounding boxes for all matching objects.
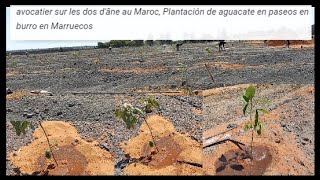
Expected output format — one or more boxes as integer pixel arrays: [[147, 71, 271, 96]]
[[122, 115, 203, 175]]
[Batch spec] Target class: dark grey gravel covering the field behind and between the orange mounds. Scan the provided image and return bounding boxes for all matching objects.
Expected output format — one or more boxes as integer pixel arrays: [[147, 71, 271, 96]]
[[6, 42, 314, 175]]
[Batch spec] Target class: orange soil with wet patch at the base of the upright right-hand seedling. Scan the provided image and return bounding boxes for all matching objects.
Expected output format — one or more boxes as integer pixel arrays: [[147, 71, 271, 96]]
[[204, 110, 314, 175]]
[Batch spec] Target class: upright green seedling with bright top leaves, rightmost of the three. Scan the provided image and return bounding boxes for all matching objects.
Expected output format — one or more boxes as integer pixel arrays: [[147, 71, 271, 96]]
[[242, 85, 271, 159]]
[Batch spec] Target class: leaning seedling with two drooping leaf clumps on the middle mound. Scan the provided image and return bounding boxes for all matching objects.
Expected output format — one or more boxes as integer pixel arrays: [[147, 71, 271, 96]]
[[115, 97, 160, 152]]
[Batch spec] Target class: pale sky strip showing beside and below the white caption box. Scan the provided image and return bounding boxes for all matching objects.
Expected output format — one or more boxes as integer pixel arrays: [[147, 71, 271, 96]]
[[6, 7, 314, 51]]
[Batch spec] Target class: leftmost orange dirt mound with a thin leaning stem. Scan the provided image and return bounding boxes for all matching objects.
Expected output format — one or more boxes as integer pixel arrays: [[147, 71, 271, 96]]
[[9, 121, 114, 175]]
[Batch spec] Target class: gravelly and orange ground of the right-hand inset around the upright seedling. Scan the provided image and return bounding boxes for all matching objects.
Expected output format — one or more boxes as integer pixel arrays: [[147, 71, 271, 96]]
[[203, 84, 315, 175]]
